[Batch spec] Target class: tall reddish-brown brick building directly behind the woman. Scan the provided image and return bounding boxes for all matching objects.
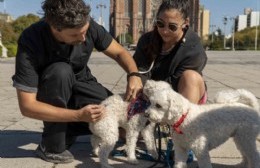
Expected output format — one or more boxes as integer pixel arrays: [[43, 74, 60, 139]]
[[109, 0, 200, 44]]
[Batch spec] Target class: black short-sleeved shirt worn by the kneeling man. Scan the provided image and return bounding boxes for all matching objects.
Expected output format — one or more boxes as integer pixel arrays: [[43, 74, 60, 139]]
[[12, 20, 112, 92]]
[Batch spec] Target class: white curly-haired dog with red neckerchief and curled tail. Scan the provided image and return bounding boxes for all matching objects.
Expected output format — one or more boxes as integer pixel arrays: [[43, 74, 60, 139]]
[[143, 80, 260, 168]]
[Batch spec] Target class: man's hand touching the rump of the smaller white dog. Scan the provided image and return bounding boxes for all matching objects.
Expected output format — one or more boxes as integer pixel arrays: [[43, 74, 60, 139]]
[[80, 105, 105, 122]]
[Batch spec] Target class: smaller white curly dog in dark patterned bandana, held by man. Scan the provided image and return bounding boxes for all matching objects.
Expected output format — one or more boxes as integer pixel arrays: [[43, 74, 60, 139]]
[[89, 95, 158, 168]]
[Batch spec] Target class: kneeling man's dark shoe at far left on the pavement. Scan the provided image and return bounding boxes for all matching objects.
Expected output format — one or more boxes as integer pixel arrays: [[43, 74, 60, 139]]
[[35, 144, 74, 163]]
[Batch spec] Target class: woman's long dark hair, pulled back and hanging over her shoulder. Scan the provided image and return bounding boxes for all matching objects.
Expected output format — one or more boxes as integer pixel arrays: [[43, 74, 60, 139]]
[[144, 0, 191, 64]]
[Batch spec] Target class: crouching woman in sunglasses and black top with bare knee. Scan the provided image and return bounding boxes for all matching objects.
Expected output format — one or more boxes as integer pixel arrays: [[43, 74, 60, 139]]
[[132, 0, 207, 103]]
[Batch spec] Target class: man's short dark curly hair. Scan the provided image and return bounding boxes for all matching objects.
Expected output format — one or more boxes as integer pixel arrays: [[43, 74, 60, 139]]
[[42, 0, 91, 31]]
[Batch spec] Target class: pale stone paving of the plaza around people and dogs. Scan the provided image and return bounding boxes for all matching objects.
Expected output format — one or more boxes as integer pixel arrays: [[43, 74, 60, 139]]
[[0, 51, 260, 168]]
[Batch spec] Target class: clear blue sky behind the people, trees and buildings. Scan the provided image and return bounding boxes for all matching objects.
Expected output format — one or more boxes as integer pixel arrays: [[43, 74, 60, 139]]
[[0, 0, 260, 34]]
